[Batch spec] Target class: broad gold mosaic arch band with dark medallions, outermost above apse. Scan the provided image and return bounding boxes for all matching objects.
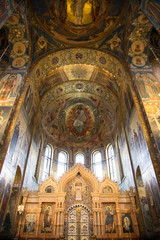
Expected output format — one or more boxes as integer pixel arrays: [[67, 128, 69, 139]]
[[30, 48, 128, 90]]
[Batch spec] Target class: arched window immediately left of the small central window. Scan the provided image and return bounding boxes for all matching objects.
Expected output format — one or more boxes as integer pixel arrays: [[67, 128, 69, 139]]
[[57, 151, 68, 178]]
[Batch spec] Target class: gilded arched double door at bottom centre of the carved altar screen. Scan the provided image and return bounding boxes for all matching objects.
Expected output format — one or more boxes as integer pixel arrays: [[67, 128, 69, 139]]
[[68, 206, 89, 240]]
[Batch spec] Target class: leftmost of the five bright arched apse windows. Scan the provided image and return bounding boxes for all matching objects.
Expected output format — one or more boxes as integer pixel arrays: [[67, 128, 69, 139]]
[[42, 145, 52, 181]]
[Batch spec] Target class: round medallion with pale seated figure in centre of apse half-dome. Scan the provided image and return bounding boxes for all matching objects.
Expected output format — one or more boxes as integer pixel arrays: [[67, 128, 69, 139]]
[[59, 98, 99, 142]]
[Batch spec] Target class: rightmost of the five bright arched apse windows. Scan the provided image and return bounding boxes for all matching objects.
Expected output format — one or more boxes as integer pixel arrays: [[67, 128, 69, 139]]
[[107, 144, 117, 181]]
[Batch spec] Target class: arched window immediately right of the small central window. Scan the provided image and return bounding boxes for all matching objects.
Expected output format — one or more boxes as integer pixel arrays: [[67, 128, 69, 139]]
[[92, 151, 103, 180]]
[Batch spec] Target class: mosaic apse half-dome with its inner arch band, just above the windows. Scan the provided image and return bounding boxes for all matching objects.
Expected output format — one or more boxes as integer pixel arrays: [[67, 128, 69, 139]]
[[40, 77, 119, 146]]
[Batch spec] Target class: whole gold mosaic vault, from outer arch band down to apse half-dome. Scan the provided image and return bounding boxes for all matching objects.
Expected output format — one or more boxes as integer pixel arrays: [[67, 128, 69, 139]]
[[27, 48, 129, 147]]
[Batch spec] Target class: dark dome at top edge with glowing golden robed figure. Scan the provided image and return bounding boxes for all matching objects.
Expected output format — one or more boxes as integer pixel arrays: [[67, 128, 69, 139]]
[[31, 0, 128, 44]]
